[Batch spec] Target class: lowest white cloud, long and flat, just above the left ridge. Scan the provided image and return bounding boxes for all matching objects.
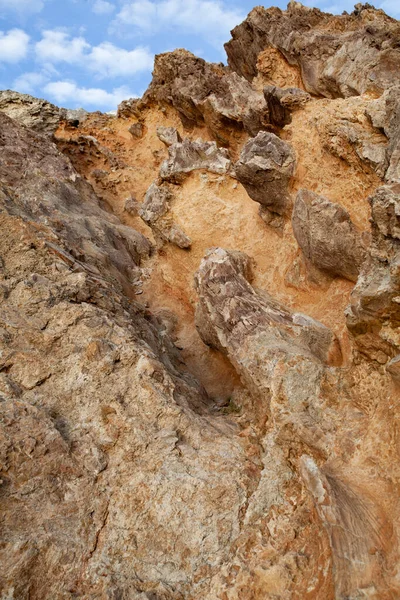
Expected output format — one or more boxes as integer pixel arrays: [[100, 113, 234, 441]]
[[43, 81, 135, 110]]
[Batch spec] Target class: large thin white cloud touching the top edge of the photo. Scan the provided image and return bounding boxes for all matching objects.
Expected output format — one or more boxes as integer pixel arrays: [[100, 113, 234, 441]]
[[112, 0, 246, 45]]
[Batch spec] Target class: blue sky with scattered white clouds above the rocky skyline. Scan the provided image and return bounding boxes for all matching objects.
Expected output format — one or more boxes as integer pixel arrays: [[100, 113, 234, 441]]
[[0, 0, 400, 111]]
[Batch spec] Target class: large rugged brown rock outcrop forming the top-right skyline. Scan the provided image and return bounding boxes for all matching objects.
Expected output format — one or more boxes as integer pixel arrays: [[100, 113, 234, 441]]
[[225, 2, 400, 98]]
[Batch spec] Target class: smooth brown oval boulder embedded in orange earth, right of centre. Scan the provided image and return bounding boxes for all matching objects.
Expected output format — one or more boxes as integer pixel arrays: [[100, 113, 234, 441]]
[[292, 190, 365, 281]]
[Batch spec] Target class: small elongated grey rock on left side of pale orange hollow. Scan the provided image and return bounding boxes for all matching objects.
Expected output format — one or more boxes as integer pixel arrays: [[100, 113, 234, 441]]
[[139, 183, 192, 248]]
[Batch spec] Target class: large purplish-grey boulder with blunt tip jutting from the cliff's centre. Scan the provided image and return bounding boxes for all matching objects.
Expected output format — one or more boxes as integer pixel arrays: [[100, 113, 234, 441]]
[[195, 248, 340, 374]]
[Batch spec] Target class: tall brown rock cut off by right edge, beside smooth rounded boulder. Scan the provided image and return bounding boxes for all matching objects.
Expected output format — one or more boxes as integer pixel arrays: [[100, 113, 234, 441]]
[[347, 184, 400, 364]]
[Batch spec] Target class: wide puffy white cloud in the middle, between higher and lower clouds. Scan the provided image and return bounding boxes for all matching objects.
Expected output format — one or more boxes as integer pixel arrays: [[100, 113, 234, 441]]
[[35, 31, 153, 78]]
